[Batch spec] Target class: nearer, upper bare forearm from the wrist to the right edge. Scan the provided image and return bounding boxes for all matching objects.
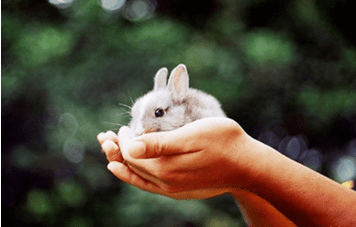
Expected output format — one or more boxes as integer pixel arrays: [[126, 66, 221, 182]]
[[241, 137, 356, 226]]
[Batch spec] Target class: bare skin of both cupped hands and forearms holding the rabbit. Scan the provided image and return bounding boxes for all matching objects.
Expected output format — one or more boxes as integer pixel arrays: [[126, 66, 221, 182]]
[[98, 118, 356, 226]]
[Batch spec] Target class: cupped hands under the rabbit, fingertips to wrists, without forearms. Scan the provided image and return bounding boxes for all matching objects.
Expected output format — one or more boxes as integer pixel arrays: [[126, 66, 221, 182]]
[[98, 118, 258, 199]]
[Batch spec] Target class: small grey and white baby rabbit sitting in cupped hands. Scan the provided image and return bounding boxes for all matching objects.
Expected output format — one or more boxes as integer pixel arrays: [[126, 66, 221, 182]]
[[129, 64, 226, 136]]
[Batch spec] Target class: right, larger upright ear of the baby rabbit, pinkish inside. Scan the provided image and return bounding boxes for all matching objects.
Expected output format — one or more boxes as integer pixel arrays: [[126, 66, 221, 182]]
[[168, 64, 189, 100]]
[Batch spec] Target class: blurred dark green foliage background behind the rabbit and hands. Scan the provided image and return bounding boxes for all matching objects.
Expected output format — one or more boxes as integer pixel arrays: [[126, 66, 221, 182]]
[[1, 0, 356, 227]]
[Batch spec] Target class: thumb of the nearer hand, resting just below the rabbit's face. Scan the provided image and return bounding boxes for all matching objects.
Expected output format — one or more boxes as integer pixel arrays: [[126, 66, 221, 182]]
[[127, 130, 195, 158]]
